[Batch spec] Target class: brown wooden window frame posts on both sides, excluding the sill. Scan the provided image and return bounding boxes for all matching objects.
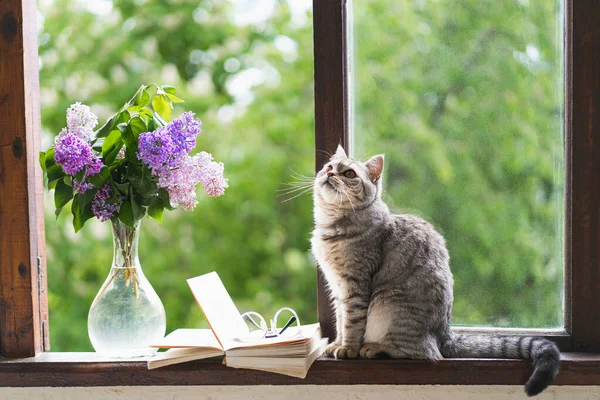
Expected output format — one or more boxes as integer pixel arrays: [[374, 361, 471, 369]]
[[0, 0, 600, 362]]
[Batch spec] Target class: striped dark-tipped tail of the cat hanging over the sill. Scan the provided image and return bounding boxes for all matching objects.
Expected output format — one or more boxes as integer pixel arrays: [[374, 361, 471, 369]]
[[440, 333, 560, 396]]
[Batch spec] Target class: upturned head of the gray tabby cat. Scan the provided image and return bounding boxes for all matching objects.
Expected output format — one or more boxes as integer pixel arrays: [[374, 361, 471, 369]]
[[314, 146, 383, 209]]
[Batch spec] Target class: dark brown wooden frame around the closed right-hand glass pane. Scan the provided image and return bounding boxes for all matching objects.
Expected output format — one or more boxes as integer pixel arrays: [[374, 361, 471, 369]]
[[313, 0, 600, 352]]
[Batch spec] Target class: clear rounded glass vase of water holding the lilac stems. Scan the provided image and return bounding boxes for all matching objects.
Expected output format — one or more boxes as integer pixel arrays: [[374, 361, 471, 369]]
[[88, 220, 167, 357]]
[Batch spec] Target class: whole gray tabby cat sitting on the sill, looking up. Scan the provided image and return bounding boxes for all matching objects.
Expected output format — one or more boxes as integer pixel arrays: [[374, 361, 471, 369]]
[[312, 147, 560, 396]]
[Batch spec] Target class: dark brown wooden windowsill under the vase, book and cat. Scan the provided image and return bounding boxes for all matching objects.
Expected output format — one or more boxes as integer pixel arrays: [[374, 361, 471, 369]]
[[0, 353, 600, 387]]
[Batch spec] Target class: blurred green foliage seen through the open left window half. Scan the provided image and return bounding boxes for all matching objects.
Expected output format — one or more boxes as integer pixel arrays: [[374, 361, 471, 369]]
[[37, 0, 316, 351]]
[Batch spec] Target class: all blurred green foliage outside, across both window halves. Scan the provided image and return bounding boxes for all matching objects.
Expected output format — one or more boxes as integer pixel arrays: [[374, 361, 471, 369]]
[[38, 0, 563, 351]]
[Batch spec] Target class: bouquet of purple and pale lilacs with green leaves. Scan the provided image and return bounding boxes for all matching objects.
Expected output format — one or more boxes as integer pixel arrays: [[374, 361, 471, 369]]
[[40, 84, 228, 232]]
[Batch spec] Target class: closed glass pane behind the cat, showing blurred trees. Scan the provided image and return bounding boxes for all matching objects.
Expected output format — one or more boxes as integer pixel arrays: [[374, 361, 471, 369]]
[[348, 0, 564, 327]]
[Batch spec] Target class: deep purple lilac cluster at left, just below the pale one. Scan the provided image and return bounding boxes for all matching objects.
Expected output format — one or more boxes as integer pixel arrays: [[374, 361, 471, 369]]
[[54, 129, 94, 175]]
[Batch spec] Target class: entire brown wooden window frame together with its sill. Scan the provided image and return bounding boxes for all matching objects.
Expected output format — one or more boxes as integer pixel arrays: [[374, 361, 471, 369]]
[[0, 0, 600, 386]]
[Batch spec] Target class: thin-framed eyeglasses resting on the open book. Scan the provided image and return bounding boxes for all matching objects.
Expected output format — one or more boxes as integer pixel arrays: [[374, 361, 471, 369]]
[[236, 307, 301, 343]]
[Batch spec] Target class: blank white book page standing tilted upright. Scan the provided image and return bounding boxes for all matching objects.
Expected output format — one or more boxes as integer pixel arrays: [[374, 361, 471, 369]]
[[187, 272, 249, 349]]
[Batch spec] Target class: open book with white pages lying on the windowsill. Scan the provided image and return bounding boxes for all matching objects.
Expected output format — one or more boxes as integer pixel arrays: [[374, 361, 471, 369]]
[[148, 272, 327, 378]]
